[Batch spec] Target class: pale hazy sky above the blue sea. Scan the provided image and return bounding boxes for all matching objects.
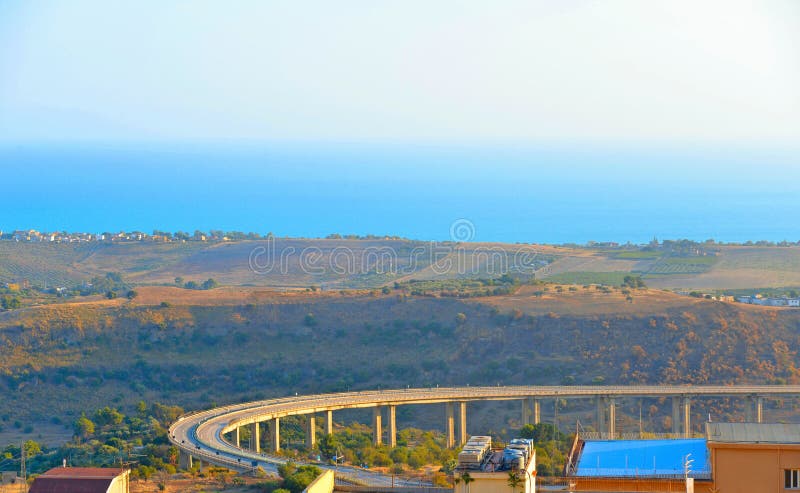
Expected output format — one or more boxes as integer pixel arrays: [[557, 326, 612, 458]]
[[0, 0, 800, 147]]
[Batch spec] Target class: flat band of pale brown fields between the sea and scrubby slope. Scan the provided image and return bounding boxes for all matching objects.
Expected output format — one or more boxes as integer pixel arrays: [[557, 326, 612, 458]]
[[0, 239, 800, 290]]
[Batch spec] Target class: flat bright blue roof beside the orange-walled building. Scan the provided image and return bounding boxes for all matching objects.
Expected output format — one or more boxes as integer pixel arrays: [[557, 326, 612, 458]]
[[575, 438, 711, 477]]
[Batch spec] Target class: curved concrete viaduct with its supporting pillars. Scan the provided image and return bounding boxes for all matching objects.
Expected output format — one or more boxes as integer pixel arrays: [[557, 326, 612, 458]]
[[169, 385, 800, 469]]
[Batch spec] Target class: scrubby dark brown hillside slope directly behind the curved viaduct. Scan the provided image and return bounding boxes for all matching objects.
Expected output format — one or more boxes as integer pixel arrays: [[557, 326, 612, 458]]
[[0, 287, 800, 442]]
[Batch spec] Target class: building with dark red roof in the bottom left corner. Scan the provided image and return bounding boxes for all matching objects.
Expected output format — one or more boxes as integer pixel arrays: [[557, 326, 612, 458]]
[[29, 467, 130, 493]]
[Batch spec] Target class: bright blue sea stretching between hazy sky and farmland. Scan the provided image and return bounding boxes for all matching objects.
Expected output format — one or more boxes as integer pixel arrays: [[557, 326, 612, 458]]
[[0, 143, 800, 243]]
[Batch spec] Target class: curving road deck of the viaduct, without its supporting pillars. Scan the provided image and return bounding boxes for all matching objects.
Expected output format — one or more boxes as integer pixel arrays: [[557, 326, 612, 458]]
[[169, 385, 800, 480]]
